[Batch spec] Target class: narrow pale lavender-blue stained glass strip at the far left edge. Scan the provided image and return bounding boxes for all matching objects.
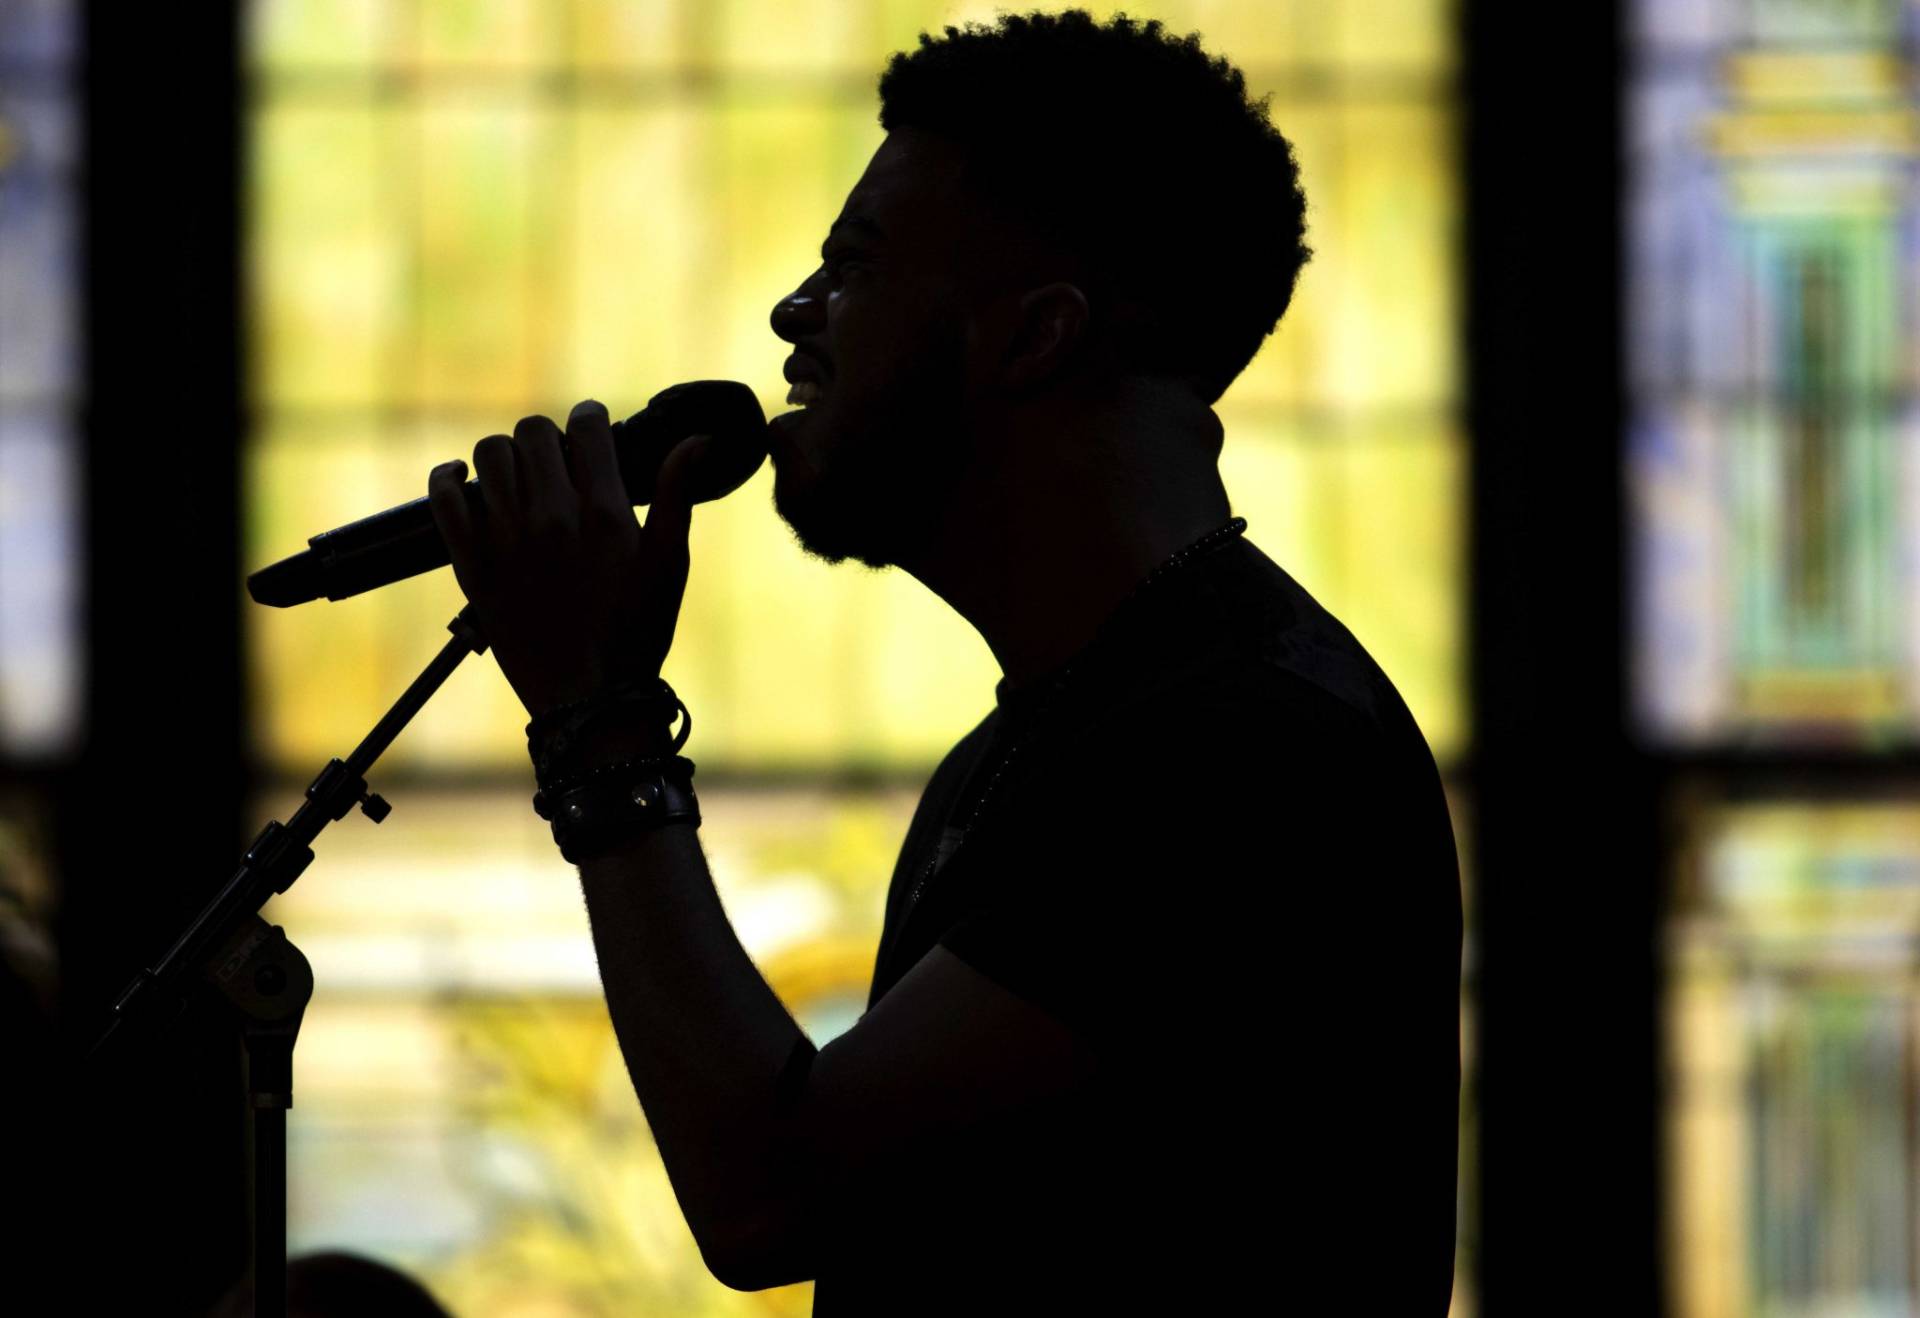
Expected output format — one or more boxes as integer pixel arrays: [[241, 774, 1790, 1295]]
[[0, 0, 84, 757]]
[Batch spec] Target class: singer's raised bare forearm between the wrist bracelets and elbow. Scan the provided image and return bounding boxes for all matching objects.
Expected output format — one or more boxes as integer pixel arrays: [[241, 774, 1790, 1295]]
[[580, 822, 804, 1274]]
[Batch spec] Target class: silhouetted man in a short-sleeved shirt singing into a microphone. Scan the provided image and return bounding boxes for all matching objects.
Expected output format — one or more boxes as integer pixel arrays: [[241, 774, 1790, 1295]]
[[430, 10, 1461, 1318]]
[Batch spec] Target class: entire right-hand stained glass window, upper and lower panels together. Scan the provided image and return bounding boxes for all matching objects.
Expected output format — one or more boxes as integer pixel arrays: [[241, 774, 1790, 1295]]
[[1626, 0, 1920, 1318]]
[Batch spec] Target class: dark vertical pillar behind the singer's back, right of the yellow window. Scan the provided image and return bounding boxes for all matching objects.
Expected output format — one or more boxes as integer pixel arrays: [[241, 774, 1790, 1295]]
[[1461, 0, 1665, 1318]]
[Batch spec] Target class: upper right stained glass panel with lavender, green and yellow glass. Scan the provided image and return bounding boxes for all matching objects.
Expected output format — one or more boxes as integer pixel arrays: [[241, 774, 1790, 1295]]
[[1628, 0, 1920, 747]]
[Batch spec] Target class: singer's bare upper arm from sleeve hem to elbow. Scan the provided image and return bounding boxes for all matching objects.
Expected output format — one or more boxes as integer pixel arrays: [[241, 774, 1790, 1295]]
[[728, 945, 1094, 1291]]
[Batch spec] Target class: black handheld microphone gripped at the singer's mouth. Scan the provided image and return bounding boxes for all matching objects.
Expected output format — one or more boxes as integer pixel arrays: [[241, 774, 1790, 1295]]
[[246, 380, 766, 609]]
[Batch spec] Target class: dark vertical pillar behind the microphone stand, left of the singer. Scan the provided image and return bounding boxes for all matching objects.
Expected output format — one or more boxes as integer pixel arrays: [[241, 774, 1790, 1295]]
[[62, 2, 248, 1314]]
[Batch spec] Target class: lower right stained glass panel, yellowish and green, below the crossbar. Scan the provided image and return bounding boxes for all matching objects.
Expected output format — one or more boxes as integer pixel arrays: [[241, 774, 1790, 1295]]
[[1667, 801, 1920, 1318]]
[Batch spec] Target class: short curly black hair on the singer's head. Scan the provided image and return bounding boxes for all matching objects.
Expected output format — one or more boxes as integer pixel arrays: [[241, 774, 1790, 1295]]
[[879, 10, 1313, 405]]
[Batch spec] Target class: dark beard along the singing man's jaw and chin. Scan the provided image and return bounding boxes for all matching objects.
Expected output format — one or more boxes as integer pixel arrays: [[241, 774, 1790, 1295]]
[[774, 315, 973, 571]]
